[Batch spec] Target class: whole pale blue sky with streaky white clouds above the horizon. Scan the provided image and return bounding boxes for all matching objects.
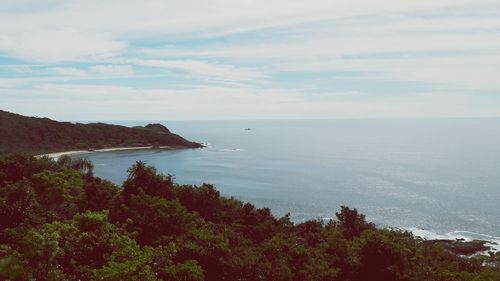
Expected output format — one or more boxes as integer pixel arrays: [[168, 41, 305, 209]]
[[0, 0, 500, 120]]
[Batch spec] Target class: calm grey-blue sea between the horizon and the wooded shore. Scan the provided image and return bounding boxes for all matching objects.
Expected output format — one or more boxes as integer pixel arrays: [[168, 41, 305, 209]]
[[76, 119, 500, 245]]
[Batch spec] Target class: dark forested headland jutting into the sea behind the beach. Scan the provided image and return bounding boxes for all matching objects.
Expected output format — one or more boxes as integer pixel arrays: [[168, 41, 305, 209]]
[[0, 110, 201, 154]]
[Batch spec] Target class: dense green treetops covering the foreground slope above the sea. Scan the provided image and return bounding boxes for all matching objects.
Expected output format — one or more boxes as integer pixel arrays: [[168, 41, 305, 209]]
[[0, 155, 500, 281]]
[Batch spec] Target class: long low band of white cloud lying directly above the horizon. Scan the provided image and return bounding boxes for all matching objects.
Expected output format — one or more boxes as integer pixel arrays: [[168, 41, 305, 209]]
[[0, 83, 500, 120]]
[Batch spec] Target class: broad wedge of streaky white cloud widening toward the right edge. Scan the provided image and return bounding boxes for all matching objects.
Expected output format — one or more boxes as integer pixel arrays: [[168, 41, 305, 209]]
[[136, 7, 500, 89]]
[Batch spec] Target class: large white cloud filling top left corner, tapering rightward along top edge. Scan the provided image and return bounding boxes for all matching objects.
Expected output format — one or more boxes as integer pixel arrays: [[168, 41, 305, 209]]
[[0, 0, 488, 61]]
